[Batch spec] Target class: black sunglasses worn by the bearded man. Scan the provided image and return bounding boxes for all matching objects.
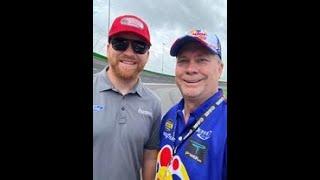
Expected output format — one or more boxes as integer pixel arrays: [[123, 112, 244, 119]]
[[110, 37, 150, 54]]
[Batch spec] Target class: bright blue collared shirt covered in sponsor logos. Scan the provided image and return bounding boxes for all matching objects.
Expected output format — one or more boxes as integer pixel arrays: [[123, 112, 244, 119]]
[[157, 89, 227, 180]]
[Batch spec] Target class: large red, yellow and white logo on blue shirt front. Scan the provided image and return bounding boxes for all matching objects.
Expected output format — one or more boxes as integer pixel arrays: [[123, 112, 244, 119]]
[[156, 145, 190, 180]]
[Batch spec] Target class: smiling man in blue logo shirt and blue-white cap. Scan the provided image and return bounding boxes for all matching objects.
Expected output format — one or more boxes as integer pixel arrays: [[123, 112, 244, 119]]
[[156, 30, 227, 180]]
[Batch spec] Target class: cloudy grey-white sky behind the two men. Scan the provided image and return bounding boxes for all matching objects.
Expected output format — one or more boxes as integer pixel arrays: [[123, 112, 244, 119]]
[[93, 0, 227, 81]]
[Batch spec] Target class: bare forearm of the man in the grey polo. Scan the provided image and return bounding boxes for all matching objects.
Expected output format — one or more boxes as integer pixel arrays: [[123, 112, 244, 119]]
[[142, 149, 158, 180]]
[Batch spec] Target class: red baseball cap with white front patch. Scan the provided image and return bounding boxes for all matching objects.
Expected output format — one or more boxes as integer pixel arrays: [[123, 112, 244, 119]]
[[109, 15, 151, 45]]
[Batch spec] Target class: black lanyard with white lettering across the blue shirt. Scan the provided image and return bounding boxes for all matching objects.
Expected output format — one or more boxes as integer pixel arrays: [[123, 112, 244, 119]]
[[172, 96, 224, 157]]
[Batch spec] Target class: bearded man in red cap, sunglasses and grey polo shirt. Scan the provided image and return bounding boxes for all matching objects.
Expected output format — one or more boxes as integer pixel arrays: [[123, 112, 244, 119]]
[[93, 15, 161, 180]]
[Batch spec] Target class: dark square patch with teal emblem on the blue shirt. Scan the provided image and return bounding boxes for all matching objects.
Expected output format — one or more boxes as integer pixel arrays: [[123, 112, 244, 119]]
[[184, 140, 207, 163]]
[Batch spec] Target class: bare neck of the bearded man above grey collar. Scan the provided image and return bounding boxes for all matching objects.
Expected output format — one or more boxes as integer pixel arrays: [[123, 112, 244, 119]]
[[106, 68, 139, 95]]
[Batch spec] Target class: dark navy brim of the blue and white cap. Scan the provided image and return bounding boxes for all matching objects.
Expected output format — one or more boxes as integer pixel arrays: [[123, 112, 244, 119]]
[[170, 35, 217, 56]]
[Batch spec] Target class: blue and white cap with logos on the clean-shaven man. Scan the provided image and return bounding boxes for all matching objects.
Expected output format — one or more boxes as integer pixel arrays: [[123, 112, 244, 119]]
[[170, 30, 221, 59]]
